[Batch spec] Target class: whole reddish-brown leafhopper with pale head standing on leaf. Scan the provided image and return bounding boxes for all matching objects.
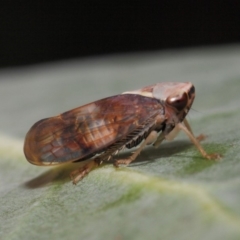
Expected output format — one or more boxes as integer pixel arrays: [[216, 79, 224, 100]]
[[24, 82, 219, 184]]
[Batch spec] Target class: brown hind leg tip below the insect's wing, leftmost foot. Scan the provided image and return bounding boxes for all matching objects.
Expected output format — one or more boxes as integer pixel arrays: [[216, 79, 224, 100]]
[[70, 158, 101, 184]]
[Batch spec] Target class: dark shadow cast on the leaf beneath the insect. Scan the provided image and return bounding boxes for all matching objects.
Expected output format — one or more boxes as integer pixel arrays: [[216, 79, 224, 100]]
[[23, 140, 193, 189]]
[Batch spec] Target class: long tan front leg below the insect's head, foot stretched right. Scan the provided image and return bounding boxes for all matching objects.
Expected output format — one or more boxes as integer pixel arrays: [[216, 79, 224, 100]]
[[176, 122, 221, 160]]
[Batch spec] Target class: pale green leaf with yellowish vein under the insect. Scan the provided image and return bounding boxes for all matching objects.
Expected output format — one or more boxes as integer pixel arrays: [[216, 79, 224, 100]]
[[0, 46, 240, 240]]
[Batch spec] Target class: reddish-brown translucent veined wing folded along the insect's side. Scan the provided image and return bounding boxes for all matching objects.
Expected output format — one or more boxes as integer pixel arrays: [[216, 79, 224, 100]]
[[24, 94, 162, 165]]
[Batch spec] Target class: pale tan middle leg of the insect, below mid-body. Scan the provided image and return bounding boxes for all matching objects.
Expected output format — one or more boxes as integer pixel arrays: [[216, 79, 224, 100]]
[[114, 131, 158, 167]]
